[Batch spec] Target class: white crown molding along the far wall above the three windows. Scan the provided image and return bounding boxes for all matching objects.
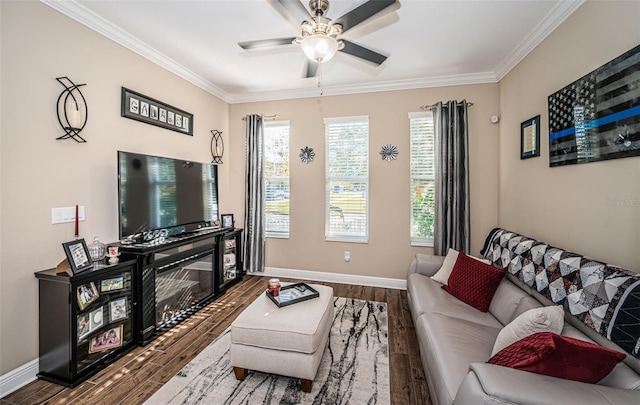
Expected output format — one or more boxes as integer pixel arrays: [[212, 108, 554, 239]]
[[229, 72, 498, 104]]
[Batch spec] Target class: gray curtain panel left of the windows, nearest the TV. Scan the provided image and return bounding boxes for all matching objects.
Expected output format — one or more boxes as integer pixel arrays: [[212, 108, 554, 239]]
[[243, 114, 264, 272]]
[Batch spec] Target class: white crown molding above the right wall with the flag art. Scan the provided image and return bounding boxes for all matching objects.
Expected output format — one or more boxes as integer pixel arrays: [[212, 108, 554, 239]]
[[495, 0, 586, 81]]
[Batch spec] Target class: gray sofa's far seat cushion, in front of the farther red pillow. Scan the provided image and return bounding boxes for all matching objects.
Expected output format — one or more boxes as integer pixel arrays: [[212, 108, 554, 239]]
[[407, 274, 503, 329]]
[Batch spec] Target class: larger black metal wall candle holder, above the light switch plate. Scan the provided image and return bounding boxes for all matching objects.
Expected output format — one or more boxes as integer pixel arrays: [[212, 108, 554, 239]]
[[56, 76, 89, 143]]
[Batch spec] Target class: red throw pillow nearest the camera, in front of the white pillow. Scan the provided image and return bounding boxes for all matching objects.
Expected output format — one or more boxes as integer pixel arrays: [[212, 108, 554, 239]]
[[487, 332, 626, 384]]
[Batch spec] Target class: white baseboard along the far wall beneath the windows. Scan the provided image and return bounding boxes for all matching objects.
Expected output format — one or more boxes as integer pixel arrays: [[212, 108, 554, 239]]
[[248, 267, 407, 290]]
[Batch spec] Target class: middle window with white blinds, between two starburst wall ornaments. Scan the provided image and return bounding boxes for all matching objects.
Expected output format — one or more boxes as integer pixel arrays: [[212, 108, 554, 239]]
[[324, 117, 369, 242]]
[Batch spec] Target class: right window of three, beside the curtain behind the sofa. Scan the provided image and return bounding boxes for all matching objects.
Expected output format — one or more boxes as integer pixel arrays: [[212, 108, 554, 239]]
[[409, 112, 435, 246]]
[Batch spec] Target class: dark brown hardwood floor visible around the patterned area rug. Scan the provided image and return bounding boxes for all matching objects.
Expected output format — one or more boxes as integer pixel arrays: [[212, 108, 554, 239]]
[[0, 276, 431, 405]]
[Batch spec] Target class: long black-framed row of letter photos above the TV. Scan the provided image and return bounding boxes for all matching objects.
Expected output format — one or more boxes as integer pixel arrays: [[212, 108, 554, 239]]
[[120, 87, 193, 136]]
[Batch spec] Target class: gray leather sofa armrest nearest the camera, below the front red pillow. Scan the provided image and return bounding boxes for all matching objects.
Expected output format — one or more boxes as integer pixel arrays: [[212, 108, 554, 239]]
[[454, 363, 640, 405]]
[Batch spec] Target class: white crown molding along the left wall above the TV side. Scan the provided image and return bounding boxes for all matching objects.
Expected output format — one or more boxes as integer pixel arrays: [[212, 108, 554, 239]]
[[40, 0, 231, 102]]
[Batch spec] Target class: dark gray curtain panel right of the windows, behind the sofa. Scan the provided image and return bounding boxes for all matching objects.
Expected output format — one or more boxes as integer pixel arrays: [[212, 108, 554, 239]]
[[432, 100, 470, 256]]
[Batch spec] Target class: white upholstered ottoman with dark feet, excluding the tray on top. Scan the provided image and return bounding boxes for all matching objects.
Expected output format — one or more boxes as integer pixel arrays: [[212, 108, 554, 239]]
[[231, 284, 334, 392]]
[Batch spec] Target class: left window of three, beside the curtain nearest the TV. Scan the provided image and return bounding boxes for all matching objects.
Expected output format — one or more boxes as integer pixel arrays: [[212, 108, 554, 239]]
[[264, 121, 289, 238]]
